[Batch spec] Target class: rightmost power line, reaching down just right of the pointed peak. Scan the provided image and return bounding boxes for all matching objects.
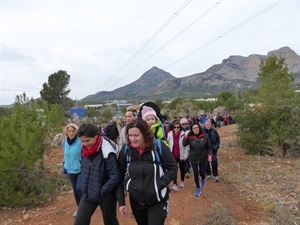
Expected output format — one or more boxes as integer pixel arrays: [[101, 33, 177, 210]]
[[164, 0, 285, 69]]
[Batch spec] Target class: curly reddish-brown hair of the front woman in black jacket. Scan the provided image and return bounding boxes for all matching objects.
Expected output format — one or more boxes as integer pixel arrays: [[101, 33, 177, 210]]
[[126, 117, 154, 147]]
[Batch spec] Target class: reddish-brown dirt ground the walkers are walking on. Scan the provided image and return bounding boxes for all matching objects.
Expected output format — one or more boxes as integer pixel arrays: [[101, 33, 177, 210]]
[[0, 125, 300, 225]]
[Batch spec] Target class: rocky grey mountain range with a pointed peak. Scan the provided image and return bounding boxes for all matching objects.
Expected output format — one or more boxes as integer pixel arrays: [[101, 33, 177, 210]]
[[80, 47, 300, 102]]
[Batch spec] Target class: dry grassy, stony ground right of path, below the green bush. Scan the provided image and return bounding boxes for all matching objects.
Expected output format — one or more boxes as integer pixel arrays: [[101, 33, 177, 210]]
[[227, 144, 300, 225]]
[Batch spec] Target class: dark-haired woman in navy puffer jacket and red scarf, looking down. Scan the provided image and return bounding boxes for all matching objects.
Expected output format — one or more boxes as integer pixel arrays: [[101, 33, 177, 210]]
[[74, 124, 122, 225]]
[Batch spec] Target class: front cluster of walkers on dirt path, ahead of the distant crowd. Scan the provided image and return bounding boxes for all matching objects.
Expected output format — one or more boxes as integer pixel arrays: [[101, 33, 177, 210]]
[[62, 103, 220, 225]]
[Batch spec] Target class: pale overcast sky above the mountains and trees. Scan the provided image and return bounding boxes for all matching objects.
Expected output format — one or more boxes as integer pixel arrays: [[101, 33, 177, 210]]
[[0, 0, 300, 105]]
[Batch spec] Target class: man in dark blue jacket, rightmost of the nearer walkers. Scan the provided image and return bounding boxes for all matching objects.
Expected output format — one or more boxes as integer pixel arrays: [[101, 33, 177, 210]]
[[204, 120, 220, 182]]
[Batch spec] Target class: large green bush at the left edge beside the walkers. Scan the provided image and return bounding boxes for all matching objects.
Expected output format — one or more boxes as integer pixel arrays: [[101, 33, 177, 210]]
[[0, 96, 63, 207]]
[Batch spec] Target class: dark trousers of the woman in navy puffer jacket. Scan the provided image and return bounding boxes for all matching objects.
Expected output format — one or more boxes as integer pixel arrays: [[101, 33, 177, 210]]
[[74, 193, 119, 225]]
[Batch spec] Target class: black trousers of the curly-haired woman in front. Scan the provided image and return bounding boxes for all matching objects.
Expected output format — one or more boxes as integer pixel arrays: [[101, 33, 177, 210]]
[[130, 198, 169, 225]]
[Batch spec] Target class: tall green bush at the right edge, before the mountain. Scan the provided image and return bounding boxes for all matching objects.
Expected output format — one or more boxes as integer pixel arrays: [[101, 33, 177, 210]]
[[236, 57, 300, 156]]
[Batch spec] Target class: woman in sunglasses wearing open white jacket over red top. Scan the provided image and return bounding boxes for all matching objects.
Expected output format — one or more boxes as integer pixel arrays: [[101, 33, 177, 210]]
[[167, 120, 189, 191]]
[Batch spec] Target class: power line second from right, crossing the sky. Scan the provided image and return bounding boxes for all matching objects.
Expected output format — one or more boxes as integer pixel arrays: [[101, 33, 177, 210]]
[[110, 0, 223, 87]]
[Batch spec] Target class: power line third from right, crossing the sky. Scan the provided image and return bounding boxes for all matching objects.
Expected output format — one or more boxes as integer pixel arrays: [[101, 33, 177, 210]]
[[99, 0, 192, 86]]
